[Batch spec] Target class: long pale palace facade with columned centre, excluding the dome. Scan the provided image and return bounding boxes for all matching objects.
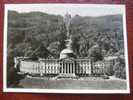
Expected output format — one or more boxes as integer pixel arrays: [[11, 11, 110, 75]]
[[15, 59, 113, 77]]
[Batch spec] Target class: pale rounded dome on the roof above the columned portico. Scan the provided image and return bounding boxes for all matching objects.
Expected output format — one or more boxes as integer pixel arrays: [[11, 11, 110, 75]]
[[60, 48, 76, 59]]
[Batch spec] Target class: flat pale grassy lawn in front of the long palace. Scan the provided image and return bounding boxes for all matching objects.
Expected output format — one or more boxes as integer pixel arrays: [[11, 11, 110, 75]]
[[19, 77, 126, 90]]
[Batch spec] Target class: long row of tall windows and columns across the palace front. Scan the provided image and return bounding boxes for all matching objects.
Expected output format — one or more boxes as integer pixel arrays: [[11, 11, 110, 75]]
[[20, 61, 109, 74]]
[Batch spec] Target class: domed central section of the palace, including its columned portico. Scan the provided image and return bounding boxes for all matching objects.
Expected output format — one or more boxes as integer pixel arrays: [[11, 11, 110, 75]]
[[58, 48, 76, 78]]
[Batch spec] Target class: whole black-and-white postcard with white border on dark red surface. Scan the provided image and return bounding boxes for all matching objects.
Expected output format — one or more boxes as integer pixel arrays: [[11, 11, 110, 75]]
[[3, 4, 130, 93]]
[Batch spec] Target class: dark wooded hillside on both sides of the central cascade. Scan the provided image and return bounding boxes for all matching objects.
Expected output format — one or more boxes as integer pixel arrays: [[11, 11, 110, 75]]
[[8, 11, 123, 58]]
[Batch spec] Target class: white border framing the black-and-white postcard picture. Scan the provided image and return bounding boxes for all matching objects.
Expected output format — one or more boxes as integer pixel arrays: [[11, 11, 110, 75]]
[[3, 3, 130, 94]]
